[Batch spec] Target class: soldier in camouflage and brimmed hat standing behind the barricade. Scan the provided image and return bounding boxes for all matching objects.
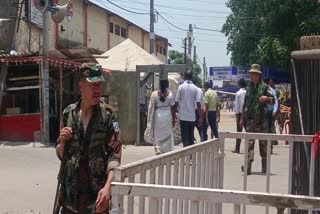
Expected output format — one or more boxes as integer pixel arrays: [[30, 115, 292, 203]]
[[240, 64, 274, 175]]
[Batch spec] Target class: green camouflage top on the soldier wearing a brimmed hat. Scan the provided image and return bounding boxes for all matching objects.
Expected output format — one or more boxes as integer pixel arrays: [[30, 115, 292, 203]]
[[243, 81, 274, 123]]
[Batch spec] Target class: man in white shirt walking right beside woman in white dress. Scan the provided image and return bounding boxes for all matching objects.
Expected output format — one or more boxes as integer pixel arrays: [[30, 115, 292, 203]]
[[175, 71, 202, 147]]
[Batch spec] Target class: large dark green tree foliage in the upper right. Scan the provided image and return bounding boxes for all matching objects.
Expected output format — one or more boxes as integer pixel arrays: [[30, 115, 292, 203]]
[[222, 0, 320, 69]]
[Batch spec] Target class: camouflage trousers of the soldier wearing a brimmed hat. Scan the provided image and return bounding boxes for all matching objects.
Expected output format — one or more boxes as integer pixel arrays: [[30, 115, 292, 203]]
[[246, 120, 268, 162]]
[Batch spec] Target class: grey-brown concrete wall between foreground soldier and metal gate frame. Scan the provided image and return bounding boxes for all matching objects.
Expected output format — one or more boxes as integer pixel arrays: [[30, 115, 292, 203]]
[[104, 71, 137, 144]]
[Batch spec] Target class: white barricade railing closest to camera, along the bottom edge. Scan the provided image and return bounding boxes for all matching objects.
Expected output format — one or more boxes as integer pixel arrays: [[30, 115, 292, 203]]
[[111, 182, 320, 214]]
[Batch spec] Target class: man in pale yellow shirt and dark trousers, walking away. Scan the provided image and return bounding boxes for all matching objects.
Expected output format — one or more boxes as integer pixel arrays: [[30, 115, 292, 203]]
[[203, 82, 219, 141]]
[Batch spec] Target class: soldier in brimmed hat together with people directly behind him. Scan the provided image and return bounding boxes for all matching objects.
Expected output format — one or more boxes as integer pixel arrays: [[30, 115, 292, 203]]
[[232, 64, 280, 175]]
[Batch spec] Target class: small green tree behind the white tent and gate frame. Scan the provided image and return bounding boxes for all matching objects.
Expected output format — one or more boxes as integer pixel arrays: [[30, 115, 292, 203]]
[[169, 50, 202, 86]]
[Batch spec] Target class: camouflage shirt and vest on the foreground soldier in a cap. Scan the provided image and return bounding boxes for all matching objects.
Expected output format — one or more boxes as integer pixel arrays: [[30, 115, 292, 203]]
[[59, 100, 121, 210]]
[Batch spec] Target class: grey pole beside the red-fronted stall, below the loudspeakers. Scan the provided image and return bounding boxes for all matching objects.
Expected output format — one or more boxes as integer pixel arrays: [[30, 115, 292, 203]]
[[40, 7, 50, 143]]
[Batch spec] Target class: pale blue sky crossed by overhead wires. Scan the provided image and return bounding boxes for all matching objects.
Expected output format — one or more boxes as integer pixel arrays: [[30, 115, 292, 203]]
[[94, 0, 230, 67]]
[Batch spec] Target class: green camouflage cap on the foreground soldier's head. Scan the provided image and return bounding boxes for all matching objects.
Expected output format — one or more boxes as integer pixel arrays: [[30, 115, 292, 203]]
[[80, 63, 105, 82]]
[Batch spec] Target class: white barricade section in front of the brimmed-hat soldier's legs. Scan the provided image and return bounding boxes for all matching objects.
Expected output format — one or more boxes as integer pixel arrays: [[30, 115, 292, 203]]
[[220, 132, 315, 214]]
